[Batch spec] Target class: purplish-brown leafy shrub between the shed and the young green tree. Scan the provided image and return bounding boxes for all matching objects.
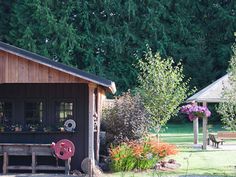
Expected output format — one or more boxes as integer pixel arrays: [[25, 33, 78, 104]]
[[101, 92, 148, 144]]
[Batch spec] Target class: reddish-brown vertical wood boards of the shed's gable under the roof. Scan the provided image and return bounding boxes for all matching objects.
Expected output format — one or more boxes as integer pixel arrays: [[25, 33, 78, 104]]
[[0, 51, 89, 83]]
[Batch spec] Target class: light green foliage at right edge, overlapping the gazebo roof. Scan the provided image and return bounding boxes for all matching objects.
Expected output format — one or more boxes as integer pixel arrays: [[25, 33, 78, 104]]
[[218, 44, 236, 131]]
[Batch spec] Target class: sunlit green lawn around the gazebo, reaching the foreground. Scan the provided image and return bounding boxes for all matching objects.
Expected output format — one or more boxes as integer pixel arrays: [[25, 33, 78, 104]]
[[106, 124, 236, 177]]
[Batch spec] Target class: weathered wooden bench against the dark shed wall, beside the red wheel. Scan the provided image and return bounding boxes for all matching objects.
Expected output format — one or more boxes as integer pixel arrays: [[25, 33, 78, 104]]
[[0, 143, 71, 174]]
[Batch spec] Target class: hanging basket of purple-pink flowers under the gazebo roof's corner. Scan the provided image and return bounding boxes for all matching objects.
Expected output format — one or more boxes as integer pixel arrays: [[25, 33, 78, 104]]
[[180, 104, 211, 121]]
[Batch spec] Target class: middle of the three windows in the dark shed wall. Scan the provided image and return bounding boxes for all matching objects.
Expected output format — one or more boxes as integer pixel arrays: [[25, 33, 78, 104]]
[[25, 101, 44, 125]]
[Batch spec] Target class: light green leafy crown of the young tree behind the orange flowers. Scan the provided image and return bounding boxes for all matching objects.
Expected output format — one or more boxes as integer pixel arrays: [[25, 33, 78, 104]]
[[138, 48, 193, 128]]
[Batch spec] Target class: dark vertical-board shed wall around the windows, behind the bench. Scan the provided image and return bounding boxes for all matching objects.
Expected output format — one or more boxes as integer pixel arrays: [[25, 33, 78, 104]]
[[0, 84, 88, 169]]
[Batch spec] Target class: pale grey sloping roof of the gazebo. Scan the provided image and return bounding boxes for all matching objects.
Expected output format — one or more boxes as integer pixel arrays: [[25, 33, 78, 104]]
[[187, 74, 230, 103]]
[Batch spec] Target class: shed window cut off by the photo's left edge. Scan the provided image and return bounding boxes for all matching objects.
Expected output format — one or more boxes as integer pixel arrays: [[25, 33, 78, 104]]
[[0, 101, 12, 124]]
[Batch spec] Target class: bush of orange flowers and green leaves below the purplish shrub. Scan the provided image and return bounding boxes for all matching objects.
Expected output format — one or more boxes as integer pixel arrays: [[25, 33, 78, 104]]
[[110, 140, 177, 171]]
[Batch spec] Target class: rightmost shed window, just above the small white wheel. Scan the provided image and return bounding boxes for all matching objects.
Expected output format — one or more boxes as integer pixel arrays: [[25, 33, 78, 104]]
[[56, 101, 74, 122]]
